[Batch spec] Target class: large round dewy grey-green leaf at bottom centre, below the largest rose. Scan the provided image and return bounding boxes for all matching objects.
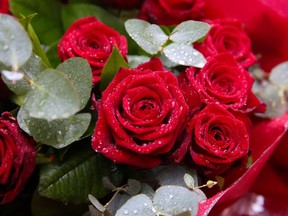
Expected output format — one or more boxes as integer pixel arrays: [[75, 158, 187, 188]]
[[153, 186, 198, 216]]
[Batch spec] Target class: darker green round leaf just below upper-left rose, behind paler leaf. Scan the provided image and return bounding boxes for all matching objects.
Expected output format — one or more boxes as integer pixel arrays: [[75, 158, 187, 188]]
[[56, 57, 92, 109]]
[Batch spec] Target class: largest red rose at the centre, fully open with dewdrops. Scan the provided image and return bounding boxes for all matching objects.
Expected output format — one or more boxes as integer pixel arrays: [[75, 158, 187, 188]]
[[92, 59, 188, 168]]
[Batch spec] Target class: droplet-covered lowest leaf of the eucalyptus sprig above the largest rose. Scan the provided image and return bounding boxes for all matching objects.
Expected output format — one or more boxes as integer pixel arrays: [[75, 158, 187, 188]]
[[163, 43, 206, 68]]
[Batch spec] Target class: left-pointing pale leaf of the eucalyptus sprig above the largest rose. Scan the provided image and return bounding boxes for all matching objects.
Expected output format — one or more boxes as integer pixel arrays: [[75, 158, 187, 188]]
[[125, 19, 168, 55]]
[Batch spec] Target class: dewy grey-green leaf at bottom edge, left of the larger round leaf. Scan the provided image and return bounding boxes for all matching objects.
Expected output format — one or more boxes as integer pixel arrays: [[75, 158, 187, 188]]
[[115, 194, 155, 216]]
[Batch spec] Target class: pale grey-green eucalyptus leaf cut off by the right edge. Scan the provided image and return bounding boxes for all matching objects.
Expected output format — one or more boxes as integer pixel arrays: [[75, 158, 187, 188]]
[[269, 61, 288, 90]]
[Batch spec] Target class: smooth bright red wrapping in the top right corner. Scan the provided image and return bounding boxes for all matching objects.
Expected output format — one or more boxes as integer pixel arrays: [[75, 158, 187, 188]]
[[204, 0, 288, 72]]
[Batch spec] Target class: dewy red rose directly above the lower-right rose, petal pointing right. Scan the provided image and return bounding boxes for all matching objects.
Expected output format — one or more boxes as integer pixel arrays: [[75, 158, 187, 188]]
[[186, 53, 265, 112]]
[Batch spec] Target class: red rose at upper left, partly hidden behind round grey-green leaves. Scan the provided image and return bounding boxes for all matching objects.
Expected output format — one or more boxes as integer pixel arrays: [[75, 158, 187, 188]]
[[58, 16, 128, 83]]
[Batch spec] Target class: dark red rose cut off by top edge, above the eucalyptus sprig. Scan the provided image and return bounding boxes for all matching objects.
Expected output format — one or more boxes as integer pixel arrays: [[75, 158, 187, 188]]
[[138, 0, 204, 25]]
